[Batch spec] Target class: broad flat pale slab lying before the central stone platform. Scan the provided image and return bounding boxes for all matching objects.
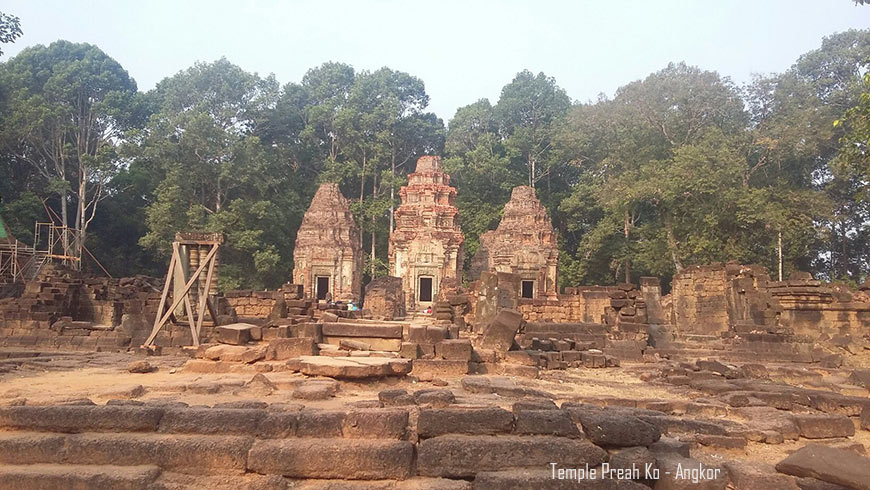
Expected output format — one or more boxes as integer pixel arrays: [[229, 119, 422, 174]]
[[287, 356, 411, 379]]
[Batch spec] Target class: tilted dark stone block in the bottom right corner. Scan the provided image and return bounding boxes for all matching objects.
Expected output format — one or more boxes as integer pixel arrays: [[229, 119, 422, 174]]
[[776, 444, 870, 490]]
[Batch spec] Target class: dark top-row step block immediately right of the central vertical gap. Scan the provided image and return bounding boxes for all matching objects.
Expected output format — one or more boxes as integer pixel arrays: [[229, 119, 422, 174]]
[[417, 407, 514, 437]]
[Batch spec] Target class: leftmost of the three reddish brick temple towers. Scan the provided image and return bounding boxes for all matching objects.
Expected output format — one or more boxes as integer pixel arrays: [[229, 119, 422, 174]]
[[293, 183, 363, 302]]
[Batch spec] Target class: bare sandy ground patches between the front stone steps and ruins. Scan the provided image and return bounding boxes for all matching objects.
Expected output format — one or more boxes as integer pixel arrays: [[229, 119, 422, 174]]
[[0, 353, 870, 464]]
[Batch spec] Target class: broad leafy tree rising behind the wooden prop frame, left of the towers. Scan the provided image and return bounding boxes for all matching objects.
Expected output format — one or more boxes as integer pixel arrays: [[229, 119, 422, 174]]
[[135, 59, 302, 288]]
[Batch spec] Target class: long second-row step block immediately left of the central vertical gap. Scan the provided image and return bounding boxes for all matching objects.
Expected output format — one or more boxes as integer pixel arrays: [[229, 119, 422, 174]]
[[248, 439, 414, 480]]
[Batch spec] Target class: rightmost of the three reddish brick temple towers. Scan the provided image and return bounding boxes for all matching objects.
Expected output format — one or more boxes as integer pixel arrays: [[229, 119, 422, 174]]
[[471, 185, 559, 299]]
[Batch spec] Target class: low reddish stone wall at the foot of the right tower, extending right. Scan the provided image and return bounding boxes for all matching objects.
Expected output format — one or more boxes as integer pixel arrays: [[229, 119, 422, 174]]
[[519, 286, 617, 323]]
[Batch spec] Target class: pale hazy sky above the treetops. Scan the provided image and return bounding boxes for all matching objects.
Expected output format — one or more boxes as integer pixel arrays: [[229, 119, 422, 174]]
[[0, 0, 870, 122]]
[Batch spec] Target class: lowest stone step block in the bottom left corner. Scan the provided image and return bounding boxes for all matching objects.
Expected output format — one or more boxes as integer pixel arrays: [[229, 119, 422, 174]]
[[0, 464, 160, 490]]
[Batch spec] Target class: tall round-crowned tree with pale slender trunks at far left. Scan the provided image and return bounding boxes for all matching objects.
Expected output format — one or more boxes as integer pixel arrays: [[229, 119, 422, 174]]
[[0, 41, 137, 252]]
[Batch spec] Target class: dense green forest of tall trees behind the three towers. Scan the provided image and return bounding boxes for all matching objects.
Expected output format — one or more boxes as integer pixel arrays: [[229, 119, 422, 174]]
[[0, 30, 870, 290]]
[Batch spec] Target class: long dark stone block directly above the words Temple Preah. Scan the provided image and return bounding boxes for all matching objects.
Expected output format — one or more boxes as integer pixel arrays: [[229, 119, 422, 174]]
[[417, 435, 607, 478]]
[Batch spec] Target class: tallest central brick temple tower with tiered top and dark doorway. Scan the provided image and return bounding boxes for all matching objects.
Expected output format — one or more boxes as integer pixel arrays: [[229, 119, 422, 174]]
[[390, 156, 465, 310]]
